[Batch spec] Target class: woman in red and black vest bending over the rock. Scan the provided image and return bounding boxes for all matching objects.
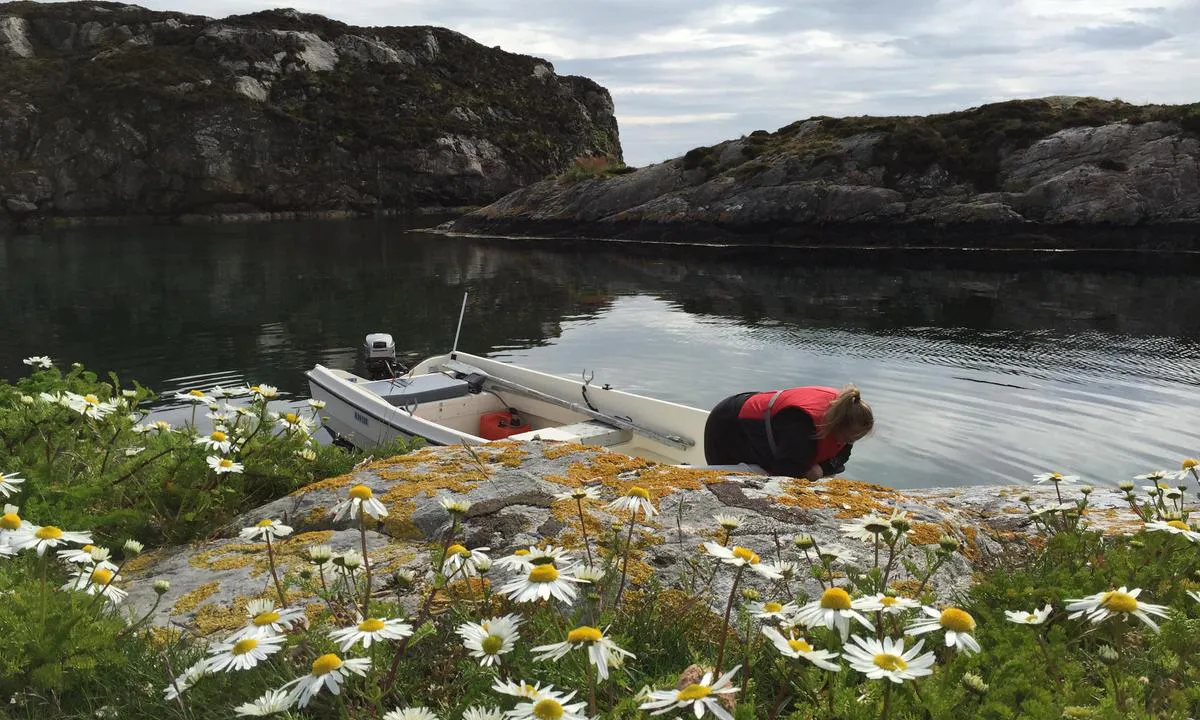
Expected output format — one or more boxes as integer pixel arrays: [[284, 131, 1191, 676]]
[[704, 385, 875, 480]]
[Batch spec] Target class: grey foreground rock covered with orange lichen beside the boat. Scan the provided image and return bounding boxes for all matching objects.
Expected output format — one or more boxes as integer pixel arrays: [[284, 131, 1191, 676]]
[[124, 442, 1138, 635]]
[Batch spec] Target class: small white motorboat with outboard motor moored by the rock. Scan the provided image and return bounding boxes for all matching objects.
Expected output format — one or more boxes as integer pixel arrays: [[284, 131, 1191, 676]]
[[306, 343, 708, 466]]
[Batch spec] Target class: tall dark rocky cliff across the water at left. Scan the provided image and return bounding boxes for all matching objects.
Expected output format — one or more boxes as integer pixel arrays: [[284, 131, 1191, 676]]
[[0, 2, 620, 228]]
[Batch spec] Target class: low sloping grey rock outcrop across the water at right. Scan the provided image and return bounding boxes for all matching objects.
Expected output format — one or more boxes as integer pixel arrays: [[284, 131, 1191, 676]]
[[449, 97, 1200, 250]]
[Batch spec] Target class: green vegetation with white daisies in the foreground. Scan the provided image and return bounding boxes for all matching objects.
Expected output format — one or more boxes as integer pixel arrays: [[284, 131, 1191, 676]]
[[0, 359, 1200, 720]]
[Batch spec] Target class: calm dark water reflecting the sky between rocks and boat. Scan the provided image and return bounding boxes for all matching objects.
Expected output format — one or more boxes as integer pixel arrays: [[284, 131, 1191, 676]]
[[0, 220, 1200, 486]]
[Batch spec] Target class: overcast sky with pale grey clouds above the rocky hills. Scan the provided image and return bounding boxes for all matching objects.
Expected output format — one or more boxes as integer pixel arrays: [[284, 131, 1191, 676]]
[[131, 0, 1200, 166]]
